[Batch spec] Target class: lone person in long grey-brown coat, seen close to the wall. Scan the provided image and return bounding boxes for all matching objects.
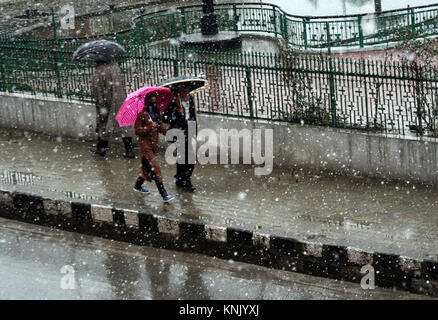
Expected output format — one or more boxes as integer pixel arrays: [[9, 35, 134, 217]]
[[91, 61, 135, 158]]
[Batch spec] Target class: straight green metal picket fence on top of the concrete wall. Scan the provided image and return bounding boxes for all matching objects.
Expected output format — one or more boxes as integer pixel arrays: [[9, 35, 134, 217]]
[[0, 45, 438, 136]]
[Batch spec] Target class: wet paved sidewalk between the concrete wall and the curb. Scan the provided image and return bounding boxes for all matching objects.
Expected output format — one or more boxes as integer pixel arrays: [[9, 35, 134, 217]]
[[0, 131, 438, 260]]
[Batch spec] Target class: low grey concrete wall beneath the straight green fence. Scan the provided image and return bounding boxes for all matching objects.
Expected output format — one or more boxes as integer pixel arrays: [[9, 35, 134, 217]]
[[0, 94, 438, 186]]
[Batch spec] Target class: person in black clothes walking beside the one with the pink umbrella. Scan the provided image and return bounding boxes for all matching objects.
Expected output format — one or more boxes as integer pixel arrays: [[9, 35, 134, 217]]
[[163, 85, 197, 192]]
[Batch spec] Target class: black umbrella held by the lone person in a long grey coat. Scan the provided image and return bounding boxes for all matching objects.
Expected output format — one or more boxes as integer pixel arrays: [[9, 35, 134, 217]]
[[73, 40, 126, 61]]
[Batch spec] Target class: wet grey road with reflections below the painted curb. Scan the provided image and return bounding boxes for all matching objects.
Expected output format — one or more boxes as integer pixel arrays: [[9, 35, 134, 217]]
[[0, 218, 427, 300]]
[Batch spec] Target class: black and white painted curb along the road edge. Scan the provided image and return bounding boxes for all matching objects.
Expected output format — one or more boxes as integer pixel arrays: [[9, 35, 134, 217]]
[[0, 190, 438, 296]]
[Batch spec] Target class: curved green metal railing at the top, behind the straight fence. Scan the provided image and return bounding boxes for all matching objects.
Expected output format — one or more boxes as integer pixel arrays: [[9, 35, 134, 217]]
[[0, 3, 438, 49]]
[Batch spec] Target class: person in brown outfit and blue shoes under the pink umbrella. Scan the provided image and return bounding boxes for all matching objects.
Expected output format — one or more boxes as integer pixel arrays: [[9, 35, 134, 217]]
[[134, 93, 174, 202]]
